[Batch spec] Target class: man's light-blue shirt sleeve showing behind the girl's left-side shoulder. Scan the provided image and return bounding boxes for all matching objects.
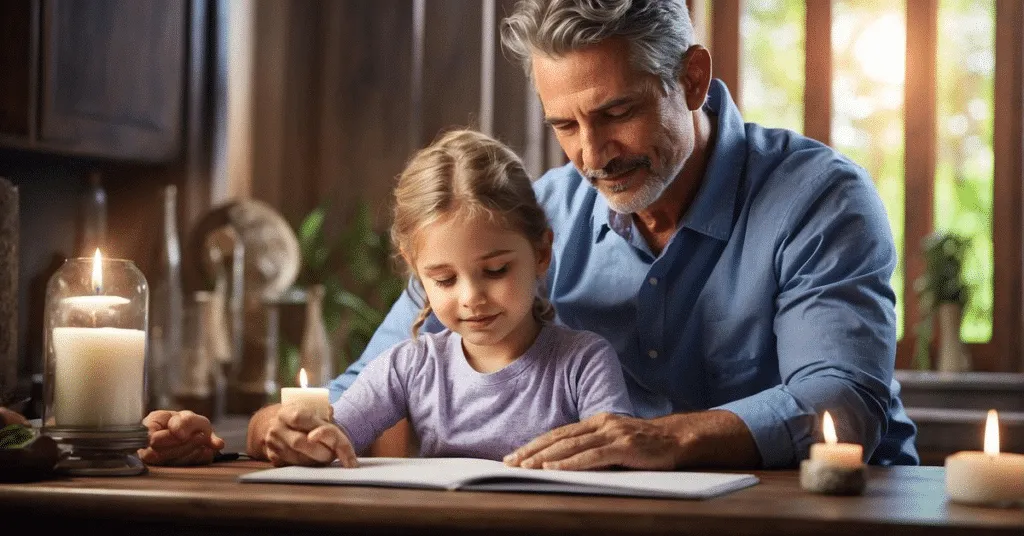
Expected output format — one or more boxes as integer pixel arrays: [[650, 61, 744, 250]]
[[327, 281, 443, 403]]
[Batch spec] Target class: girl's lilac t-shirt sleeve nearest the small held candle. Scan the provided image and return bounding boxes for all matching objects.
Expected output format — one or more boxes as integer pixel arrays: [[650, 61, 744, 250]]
[[332, 340, 422, 453]]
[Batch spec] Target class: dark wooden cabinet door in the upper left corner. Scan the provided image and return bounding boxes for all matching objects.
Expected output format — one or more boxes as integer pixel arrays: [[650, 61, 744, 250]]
[[39, 0, 187, 162]]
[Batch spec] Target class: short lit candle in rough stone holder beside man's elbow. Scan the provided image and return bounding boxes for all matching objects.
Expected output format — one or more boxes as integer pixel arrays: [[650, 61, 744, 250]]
[[800, 411, 866, 495]]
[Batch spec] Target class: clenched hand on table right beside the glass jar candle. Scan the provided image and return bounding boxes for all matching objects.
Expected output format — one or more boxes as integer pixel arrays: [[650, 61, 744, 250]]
[[138, 410, 224, 465]]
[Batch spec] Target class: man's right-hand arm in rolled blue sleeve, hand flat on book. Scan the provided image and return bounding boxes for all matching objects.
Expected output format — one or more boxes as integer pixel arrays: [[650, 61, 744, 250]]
[[507, 168, 896, 469]]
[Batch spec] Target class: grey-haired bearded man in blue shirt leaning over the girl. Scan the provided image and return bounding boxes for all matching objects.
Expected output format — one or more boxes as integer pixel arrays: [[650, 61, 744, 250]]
[[146, 0, 919, 469]]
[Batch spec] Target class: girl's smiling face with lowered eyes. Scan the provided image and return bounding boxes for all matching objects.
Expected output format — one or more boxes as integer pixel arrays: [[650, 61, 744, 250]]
[[414, 215, 551, 362]]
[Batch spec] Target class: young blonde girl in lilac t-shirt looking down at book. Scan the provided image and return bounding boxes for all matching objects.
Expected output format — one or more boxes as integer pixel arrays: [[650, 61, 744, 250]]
[[250, 130, 632, 466]]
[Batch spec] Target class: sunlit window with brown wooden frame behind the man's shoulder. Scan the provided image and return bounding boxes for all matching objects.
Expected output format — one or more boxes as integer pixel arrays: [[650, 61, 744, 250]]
[[704, 0, 1024, 371]]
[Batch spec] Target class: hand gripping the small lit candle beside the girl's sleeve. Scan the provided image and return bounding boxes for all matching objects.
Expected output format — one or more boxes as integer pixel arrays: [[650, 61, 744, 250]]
[[249, 405, 358, 467]]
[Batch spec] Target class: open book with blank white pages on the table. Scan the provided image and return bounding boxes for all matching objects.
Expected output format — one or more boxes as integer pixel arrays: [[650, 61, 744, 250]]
[[239, 458, 758, 499]]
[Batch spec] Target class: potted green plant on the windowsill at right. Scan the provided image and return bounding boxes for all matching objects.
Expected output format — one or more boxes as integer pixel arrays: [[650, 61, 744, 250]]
[[914, 233, 971, 372]]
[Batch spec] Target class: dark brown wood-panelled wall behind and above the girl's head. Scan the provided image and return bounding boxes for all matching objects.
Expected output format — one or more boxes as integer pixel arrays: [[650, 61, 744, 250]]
[[237, 0, 562, 234]]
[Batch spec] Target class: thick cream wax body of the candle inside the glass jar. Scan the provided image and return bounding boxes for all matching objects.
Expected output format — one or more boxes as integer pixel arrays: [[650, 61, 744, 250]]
[[52, 327, 145, 426]]
